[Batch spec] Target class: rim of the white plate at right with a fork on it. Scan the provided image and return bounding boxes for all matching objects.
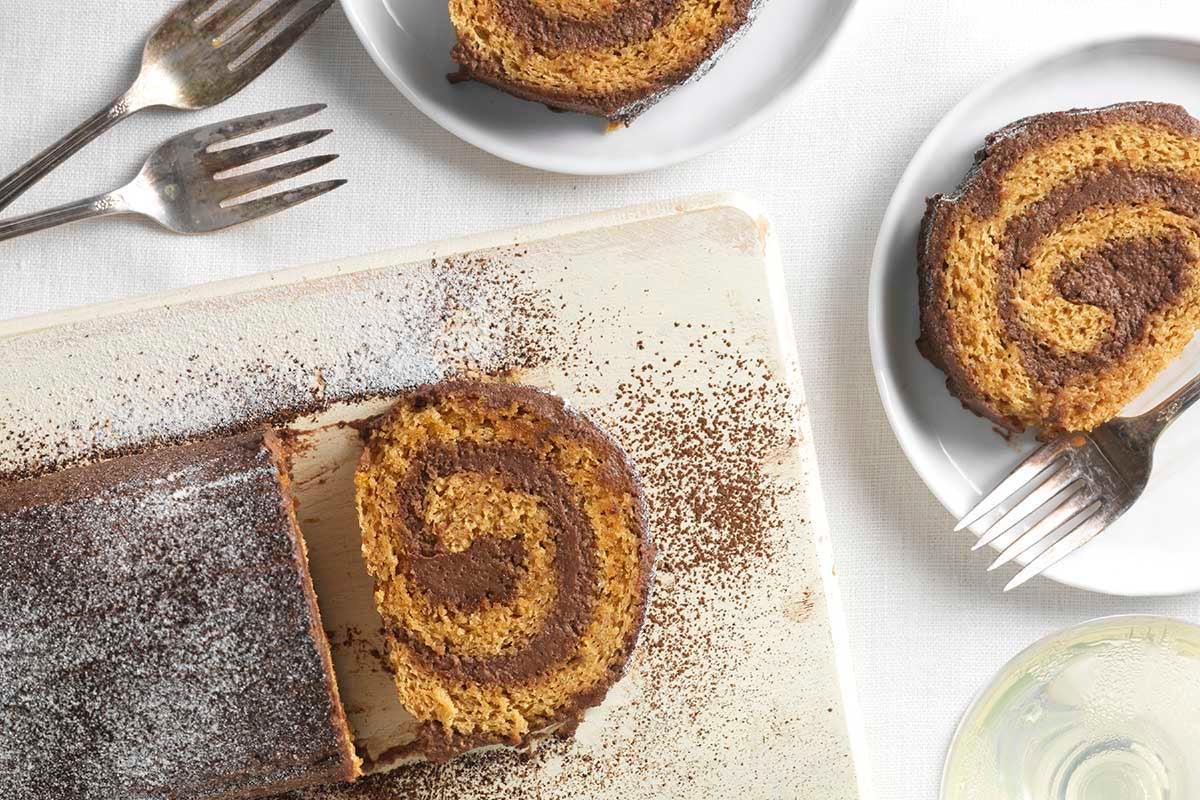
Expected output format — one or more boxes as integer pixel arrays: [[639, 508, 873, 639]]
[[866, 30, 1200, 597]]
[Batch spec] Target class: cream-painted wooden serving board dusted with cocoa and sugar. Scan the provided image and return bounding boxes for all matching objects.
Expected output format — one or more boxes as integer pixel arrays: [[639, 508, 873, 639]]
[[0, 197, 860, 800]]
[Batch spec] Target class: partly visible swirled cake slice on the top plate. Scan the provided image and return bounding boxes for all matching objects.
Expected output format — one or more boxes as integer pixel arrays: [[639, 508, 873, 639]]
[[449, 0, 761, 125]]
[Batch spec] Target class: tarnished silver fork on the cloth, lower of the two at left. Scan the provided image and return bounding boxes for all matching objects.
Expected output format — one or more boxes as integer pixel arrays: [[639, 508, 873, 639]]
[[0, 104, 346, 241]]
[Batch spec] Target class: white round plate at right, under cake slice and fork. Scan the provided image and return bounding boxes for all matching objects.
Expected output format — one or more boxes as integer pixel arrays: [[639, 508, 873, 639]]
[[868, 37, 1200, 596]]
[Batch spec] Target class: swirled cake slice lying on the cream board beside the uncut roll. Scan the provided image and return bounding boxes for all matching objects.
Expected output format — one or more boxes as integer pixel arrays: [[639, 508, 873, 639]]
[[355, 383, 653, 760]]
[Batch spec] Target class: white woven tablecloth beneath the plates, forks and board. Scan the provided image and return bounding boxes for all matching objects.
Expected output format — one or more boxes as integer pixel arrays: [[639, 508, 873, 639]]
[[0, 0, 1200, 800]]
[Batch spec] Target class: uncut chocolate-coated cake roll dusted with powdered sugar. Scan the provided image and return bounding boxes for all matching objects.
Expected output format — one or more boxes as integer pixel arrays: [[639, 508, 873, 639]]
[[0, 432, 358, 800]]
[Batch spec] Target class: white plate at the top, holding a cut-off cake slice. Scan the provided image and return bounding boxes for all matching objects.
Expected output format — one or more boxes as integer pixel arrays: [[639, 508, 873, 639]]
[[342, 0, 853, 175]]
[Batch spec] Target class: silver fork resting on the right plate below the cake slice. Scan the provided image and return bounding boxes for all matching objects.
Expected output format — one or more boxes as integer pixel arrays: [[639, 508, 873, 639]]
[[954, 377, 1200, 591]]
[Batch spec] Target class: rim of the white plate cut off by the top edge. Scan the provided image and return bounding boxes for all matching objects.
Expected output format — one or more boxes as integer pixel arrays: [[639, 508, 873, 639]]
[[341, 0, 860, 176]]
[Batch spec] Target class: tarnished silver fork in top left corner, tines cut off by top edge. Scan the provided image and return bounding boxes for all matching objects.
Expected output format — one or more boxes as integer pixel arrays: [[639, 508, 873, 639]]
[[0, 0, 334, 210]]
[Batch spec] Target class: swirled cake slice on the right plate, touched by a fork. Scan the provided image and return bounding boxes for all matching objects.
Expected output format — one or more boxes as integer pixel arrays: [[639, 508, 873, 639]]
[[919, 103, 1200, 435]]
